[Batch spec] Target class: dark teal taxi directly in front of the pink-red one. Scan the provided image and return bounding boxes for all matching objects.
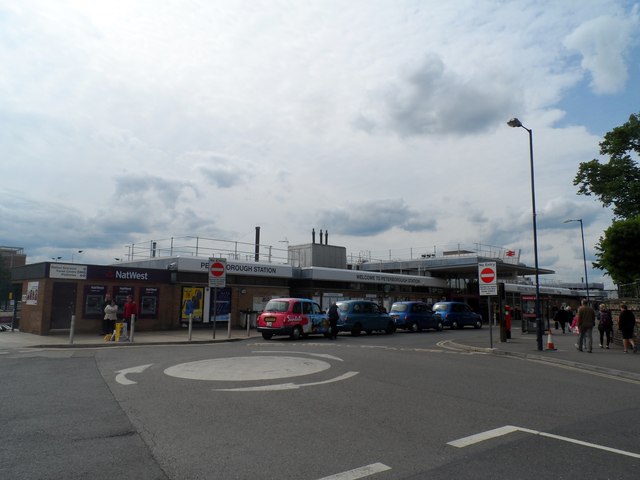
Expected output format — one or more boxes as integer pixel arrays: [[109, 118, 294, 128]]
[[337, 300, 396, 335]]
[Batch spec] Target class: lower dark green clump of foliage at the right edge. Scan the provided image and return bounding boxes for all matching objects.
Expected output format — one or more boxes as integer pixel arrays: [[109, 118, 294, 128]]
[[593, 216, 640, 285]]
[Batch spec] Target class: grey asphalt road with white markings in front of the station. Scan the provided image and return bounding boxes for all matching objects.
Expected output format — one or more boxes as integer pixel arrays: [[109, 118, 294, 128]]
[[0, 330, 640, 480]]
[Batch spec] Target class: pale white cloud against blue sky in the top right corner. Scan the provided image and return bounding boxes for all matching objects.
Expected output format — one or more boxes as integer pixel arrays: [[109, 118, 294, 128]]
[[563, 5, 640, 94]]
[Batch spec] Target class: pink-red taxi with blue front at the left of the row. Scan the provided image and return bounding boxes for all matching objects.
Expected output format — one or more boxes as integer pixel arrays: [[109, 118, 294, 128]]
[[256, 298, 329, 340]]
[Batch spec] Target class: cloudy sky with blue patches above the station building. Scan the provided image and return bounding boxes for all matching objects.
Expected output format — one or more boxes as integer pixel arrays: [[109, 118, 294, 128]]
[[0, 0, 640, 285]]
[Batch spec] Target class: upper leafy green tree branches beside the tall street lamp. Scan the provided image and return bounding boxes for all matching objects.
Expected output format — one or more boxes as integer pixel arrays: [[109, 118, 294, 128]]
[[573, 114, 640, 219]]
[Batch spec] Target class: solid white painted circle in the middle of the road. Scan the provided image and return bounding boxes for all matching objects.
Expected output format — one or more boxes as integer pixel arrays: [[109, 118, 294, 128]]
[[164, 356, 331, 382]]
